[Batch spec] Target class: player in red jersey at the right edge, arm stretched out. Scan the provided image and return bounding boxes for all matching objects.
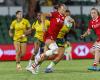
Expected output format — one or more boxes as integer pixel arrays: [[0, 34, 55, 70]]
[[81, 8, 100, 71]]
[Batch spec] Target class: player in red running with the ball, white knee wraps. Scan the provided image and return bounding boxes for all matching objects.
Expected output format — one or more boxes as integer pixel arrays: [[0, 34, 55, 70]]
[[29, 4, 65, 74]]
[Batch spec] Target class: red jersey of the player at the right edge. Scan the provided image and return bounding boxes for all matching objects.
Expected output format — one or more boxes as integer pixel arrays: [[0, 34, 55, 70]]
[[88, 17, 100, 41]]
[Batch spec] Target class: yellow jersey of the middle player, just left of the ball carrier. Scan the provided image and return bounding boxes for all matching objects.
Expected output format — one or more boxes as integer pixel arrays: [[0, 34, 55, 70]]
[[32, 20, 50, 41]]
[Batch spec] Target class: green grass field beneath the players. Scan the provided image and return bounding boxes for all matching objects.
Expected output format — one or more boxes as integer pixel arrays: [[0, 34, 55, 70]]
[[0, 60, 100, 80]]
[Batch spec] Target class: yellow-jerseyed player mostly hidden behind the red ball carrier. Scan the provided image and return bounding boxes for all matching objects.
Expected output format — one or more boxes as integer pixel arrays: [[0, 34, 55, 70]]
[[45, 10, 75, 73]]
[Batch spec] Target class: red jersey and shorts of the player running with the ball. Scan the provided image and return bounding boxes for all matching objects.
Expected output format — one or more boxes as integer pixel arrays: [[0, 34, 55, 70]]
[[44, 11, 64, 40]]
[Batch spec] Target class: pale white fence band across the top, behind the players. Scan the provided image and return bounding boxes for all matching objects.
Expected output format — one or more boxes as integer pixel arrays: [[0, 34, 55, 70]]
[[0, 6, 100, 16]]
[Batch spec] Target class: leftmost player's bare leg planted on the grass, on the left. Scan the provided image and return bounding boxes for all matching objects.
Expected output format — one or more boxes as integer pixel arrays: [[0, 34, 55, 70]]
[[14, 41, 21, 70]]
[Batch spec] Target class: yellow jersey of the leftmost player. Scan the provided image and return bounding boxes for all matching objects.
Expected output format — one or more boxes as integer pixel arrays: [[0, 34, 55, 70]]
[[10, 18, 30, 42]]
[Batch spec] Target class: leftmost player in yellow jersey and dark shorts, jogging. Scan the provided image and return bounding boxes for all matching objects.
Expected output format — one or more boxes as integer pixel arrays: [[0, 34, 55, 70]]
[[9, 11, 31, 70]]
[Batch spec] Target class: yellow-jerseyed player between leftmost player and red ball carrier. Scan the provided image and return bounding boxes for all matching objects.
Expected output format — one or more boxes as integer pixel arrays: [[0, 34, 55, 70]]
[[26, 12, 50, 70]]
